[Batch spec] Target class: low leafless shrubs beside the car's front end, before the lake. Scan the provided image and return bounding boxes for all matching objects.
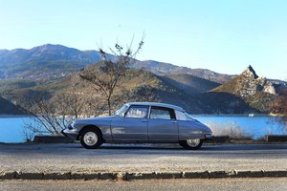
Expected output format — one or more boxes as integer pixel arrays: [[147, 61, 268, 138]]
[[25, 93, 84, 135]]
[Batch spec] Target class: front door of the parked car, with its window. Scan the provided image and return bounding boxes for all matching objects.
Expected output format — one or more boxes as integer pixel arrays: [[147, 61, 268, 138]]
[[111, 105, 149, 142]]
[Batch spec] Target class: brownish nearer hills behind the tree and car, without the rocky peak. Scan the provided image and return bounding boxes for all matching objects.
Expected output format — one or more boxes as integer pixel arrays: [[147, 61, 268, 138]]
[[0, 66, 255, 115]]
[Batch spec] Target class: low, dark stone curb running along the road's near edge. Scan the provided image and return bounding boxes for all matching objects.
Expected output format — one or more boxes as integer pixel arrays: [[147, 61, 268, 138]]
[[0, 170, 287, 181]]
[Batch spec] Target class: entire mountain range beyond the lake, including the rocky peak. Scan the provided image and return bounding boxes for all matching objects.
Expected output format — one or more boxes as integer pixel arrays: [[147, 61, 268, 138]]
[[0, 44, 286, 113]]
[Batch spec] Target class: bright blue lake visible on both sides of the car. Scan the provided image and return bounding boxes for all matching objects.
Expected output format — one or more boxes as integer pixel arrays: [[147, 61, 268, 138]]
[[0, 115, 287, 143]]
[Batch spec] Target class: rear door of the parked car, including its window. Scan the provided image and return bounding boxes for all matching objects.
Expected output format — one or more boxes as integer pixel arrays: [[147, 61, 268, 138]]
[[148, 106, 178, 142]]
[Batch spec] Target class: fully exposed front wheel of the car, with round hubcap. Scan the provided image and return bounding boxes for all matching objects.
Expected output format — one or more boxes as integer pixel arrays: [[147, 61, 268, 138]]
[[80, 127, 103, 149]]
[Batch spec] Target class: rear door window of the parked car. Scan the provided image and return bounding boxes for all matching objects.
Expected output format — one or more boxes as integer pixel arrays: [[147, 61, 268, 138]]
[[150, 106, 175, 120]]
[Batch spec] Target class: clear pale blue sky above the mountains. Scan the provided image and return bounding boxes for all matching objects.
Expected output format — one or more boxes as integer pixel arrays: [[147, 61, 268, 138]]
[[0, 0, 287, 79]]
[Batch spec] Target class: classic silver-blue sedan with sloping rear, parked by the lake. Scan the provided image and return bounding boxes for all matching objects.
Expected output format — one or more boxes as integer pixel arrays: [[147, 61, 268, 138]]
[[62, 102, 212, 149]]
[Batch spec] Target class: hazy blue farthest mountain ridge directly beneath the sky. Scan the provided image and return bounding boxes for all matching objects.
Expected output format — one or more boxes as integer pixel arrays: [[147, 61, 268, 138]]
[[0, 44, 234, 83]]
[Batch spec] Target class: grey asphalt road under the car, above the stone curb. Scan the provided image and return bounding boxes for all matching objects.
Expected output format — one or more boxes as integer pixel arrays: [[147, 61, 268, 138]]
[[0, 144, 287, 172]]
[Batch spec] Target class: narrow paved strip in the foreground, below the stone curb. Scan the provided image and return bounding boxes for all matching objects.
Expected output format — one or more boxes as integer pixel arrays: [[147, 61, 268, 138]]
[[0, 178, 287, 191]]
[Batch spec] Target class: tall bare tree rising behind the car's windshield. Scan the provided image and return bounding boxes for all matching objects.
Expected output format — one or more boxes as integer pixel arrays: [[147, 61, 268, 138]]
[[80, 40, 144, 115]]
